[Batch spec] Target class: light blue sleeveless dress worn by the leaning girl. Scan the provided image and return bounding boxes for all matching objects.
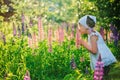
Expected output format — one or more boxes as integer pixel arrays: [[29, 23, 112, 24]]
[[88, 31, 117, 70]]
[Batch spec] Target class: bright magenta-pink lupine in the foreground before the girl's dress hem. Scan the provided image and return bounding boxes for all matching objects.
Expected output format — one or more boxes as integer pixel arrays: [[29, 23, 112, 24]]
[[94, 55, 104, 80]]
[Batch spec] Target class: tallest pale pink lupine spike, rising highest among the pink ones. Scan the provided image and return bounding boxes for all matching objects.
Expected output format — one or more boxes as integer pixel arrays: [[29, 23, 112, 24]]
[[38, 18, 44, 40]]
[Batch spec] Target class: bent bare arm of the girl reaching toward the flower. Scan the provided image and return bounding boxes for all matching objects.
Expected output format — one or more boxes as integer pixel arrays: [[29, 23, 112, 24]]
[[80, 35, 98, 54]]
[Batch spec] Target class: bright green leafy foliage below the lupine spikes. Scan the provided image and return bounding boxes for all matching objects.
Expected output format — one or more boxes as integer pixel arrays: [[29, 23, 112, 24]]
[[0, 38, 92, 80]]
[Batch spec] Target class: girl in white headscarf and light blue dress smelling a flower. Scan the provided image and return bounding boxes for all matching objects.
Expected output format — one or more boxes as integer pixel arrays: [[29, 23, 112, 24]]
[[78, 15, 117, 79]]
